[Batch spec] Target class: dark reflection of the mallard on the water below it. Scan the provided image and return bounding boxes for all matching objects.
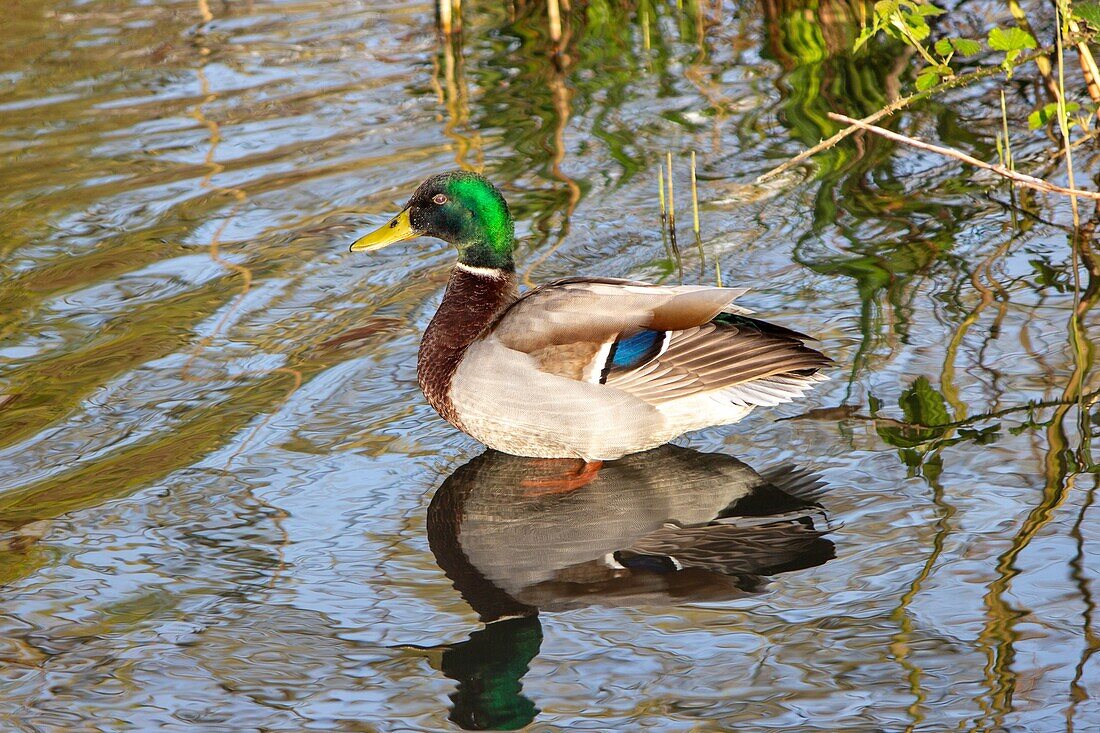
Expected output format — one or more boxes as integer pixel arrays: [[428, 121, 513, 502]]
[[428, 446, 834, 730]]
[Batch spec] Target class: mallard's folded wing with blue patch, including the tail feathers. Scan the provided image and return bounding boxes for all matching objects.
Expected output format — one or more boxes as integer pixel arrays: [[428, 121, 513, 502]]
[[494, 278, 832, 406]]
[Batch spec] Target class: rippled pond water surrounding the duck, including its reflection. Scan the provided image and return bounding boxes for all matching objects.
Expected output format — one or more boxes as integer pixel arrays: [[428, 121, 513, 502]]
[[0, 0, 1100, 731]]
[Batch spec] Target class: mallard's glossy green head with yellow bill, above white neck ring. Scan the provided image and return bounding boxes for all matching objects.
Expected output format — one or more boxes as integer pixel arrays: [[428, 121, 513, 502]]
[[351, 171, 515, 271]]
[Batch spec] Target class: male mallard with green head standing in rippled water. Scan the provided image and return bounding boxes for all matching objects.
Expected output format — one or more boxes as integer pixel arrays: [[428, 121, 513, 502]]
[[351, 171, 832, 461]]
